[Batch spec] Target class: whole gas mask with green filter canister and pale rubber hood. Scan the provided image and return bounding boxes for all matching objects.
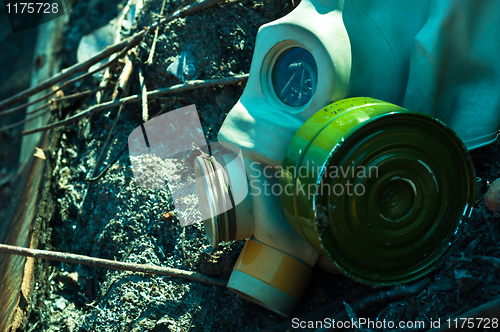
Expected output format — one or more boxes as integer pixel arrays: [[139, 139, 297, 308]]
[[132, 0, 500, 316]]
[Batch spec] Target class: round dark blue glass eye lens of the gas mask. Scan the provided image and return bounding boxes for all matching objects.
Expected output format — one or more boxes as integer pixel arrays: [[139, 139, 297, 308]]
[[273, 47, 318, 107]]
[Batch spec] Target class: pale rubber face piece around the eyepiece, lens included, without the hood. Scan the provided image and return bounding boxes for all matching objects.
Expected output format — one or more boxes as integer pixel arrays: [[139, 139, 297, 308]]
[[218, 0, 352, 166]]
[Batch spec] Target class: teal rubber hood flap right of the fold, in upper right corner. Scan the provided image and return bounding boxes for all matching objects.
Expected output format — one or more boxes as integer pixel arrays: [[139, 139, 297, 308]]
[[403, 0, 500, 149]]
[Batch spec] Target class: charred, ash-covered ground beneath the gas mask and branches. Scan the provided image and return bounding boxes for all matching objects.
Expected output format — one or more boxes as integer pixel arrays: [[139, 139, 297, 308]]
[[0, 0, 500, 331]]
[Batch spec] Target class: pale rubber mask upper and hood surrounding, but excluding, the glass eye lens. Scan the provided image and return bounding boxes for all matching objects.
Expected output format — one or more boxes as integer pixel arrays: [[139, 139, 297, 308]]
[[219, 0, 500, 166]]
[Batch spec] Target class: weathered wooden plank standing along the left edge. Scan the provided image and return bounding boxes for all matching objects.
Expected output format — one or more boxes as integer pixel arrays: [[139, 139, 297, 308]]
[[0, 11, 68, 331]]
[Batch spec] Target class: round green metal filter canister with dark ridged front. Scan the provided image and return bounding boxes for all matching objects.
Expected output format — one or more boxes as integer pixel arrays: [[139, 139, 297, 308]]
[[281, 98, 476, 285]]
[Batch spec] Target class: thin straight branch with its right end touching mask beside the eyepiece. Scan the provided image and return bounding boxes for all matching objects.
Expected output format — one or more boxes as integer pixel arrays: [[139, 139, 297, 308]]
[[22, 74, 248, 135]]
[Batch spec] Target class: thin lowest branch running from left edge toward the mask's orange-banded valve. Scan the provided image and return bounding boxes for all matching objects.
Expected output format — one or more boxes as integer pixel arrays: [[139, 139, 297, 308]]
[[0, 244, 226, 287]]
